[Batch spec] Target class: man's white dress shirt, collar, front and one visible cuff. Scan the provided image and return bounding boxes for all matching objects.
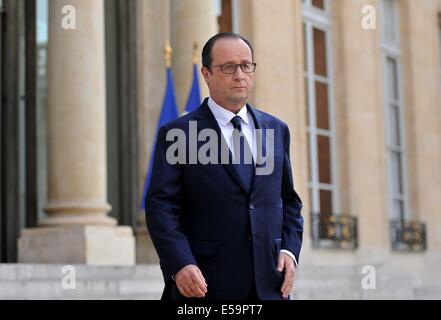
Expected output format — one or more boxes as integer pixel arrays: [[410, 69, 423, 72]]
[[208, 97, 297, 265]]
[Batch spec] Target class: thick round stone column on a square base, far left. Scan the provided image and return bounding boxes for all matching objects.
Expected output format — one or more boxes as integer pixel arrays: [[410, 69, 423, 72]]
[[19, 0, 135, 264]]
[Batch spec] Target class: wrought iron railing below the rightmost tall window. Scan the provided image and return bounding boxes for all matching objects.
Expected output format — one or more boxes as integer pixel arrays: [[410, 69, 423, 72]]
[[390, 220, 427, 251]]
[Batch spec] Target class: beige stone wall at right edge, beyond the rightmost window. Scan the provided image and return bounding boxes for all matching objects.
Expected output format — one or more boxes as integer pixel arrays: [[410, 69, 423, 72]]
[[400, 0, 441, 250]]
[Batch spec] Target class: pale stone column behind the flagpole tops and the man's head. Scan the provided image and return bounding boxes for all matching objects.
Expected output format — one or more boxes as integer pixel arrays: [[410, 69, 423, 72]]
[[171, 0, 217, 112]]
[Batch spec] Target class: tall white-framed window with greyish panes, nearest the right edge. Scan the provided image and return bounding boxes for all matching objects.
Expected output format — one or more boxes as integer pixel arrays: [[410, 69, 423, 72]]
[[381, 0, 408, 220]]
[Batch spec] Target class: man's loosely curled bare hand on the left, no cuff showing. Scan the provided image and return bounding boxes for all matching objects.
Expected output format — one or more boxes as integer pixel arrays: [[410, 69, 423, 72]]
[[175, 264, 207, 298]]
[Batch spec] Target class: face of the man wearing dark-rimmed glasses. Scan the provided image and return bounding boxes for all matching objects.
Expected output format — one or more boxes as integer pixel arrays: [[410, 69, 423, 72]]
[[201, 39, 254, 112]]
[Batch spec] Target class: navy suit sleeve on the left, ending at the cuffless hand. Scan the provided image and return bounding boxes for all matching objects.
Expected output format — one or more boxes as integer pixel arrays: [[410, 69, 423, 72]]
[[145, 126, 196, 279]]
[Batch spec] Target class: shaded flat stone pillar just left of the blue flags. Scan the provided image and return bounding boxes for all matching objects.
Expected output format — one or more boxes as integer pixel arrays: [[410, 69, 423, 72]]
[[135, 0, 170, 263]]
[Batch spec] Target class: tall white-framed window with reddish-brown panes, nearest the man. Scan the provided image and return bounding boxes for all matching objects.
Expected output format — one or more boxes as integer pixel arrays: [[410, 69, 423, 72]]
[[303, 0, 338, 214]]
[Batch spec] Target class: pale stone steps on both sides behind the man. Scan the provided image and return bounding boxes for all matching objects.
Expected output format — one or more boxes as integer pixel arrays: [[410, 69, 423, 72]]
[[0, 264, 441, 300]]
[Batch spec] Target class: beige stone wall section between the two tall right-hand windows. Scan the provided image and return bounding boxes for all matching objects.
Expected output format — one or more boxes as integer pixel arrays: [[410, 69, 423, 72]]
[[331, 0, 389, 249]]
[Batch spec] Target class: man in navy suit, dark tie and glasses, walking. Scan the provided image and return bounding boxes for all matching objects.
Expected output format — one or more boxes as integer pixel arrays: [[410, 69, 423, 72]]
[[145, 33, 303, 300]]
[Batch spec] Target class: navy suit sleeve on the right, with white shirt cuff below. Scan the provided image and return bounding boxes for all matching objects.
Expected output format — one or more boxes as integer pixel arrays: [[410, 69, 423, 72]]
[[281, 125, 303, 262]]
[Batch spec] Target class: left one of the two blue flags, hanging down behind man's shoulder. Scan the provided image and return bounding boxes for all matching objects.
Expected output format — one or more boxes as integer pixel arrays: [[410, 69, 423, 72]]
[[141, 68, 178, 209]]
